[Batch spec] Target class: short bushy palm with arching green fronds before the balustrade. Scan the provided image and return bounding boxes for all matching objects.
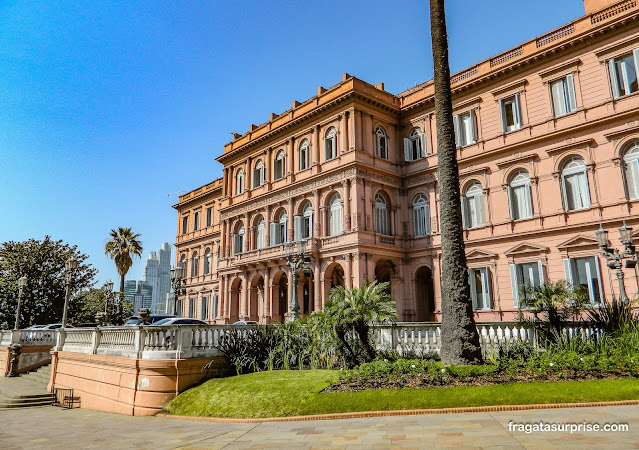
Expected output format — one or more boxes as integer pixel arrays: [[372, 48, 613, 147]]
[[324, 281, 397, 364]]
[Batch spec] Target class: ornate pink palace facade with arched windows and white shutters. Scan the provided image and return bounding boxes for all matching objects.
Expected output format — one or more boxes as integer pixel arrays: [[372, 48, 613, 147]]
[[174, 0, 639, 324]]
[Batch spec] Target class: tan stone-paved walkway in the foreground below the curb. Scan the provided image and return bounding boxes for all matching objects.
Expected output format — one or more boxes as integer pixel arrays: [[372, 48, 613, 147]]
[[0, 406, 639, 450]]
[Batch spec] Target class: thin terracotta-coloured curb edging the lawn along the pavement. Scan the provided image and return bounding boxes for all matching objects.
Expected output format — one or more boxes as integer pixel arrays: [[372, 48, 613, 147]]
[[156, 400, 639, 423]]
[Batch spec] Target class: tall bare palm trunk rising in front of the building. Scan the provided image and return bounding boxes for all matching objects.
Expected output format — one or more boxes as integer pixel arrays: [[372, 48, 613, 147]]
[[430, 0, 482, 365]]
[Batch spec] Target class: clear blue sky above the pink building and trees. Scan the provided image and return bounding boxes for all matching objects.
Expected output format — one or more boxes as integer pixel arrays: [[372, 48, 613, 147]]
[[0, 0, 584, 285]]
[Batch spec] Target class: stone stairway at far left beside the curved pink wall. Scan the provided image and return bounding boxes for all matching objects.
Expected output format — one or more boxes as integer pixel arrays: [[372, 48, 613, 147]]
[[0, 365, 53, 409]]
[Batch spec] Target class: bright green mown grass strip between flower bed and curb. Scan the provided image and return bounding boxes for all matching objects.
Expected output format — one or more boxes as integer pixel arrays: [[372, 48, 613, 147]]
[[164, 370, 639, 418]]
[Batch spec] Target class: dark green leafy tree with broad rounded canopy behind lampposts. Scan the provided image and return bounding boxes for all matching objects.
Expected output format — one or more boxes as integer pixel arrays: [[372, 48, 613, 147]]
[[0, 236, 97, 328]]
